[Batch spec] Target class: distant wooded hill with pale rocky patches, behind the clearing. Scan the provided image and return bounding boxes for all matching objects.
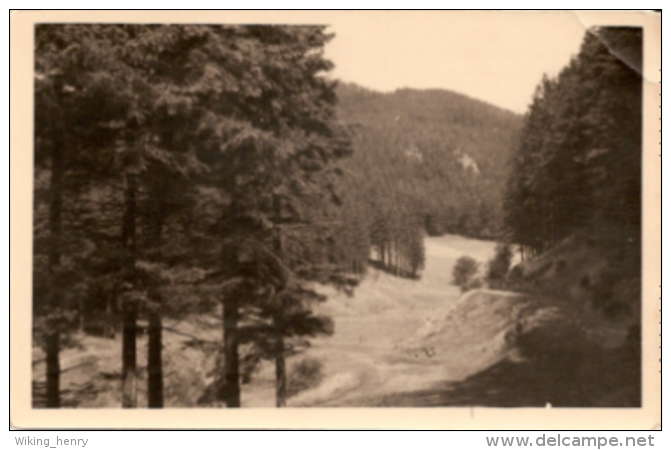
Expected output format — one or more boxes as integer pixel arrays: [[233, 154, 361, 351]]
[[338, 84, 521, 277]]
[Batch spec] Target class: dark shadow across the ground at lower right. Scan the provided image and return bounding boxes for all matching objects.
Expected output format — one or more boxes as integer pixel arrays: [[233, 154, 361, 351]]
[[348, 330, 641, 407]]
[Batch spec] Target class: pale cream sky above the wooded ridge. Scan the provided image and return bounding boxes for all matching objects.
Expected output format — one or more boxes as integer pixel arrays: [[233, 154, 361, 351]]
[[325, 11, 586, 113]]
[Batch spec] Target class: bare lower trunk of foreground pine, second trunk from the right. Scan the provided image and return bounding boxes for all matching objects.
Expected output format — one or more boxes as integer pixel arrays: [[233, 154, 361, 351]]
[[221, 292, 240, 408]]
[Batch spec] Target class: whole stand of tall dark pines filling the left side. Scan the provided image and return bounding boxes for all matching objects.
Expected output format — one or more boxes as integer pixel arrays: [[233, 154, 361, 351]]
[[33, 24, 369, 408]]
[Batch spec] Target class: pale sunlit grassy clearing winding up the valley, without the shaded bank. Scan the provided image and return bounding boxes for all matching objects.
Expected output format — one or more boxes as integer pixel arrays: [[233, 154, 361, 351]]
[[289, 236, 502, 406]]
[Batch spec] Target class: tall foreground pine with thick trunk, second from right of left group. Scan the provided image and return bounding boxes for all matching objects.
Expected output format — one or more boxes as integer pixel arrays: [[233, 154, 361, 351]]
[[142, 26, 356, 407]]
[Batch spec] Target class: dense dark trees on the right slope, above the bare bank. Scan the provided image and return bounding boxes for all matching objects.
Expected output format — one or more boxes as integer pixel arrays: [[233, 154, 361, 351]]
[[505, 28, 642, 256]]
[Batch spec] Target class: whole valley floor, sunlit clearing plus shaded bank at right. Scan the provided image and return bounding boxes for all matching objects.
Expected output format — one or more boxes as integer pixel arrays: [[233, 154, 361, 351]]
[[289, 236, 640, 407]]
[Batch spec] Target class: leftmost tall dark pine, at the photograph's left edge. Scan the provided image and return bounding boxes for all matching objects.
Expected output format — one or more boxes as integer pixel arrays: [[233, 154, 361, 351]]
[[34, 25, 136, 407]]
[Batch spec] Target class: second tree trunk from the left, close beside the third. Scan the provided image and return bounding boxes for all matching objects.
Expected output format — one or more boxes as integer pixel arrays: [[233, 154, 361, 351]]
[[121, 174, 138, 408]]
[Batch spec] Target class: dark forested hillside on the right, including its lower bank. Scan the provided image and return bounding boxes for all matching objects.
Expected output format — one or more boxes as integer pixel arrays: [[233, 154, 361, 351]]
[[505, 28, 642, 338]]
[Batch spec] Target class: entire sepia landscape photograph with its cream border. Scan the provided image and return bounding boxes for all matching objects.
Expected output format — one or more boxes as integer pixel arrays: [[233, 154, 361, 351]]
[[10, 7, 661, 429]]
